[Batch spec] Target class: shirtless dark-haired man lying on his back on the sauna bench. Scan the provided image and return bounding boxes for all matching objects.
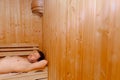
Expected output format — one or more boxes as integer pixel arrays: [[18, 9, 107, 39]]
[[0, 51, 47, 74]]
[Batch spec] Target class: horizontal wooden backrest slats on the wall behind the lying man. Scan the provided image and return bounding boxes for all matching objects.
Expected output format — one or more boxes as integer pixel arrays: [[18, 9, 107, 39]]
[[0, 43, 39, 57]]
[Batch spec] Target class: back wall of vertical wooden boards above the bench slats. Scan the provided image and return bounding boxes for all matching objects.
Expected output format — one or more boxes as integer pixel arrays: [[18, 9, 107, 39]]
[[0, 0, 42, 49]]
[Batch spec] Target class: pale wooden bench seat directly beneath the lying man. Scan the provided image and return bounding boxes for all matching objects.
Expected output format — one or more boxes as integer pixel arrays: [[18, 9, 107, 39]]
[[0, 70, 48, 80]]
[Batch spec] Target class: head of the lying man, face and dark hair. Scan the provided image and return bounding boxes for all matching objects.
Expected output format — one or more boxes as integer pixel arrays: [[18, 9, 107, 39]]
[[27, 51, 45, 63]]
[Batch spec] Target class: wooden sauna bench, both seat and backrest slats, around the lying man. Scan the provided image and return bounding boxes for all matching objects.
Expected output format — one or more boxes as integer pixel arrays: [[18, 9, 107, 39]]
[[0, 43, 48, 80]]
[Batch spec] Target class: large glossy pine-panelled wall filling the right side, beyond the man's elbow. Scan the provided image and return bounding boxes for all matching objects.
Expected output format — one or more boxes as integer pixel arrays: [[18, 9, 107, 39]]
[[43, 0, 120, 80]]
